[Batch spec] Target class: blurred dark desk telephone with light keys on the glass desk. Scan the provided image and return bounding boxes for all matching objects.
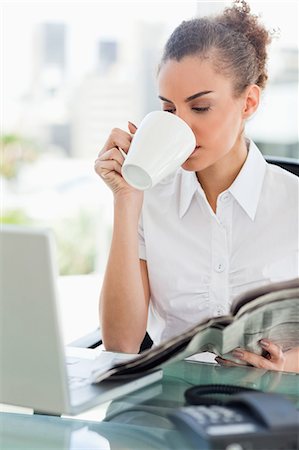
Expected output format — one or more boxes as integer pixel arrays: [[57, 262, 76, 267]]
[[169, 391, 299, 450]]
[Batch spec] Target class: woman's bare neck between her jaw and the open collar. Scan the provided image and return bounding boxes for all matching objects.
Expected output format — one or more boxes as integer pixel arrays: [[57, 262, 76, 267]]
[[196, 137, 247, 213]]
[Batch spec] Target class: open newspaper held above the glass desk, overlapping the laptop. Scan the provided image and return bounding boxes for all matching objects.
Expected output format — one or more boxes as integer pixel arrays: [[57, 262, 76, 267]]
[[92, 278, 299, 383]]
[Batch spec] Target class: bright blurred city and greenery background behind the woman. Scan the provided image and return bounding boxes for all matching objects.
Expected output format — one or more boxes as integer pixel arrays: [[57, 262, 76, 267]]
[[0, 0, 298, 275]]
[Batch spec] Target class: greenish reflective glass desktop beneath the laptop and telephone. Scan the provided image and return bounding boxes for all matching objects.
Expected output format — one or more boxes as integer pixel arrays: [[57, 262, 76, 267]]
[[0, 361, 299, 450]]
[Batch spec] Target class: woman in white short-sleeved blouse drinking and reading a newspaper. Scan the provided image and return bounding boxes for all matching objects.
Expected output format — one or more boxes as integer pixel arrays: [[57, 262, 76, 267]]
[[95, 1, 298, 370]]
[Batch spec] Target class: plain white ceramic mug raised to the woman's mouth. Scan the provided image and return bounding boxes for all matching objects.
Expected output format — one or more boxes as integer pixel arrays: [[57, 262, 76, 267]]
[[121, 111, 196, 190]]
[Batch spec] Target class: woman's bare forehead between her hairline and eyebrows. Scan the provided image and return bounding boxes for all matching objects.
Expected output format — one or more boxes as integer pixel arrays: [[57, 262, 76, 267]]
[[158, 56, 232, 99]]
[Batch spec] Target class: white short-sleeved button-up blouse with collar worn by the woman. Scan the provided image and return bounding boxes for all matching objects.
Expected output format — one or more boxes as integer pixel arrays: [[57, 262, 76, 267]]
[[139, 141, 299, 344]]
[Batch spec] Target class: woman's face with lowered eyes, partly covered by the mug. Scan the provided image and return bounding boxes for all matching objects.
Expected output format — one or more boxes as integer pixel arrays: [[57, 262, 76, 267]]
[[158, 56, 254, 171]]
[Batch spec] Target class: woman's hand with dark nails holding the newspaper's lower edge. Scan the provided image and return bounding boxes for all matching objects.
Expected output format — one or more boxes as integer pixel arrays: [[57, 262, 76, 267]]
[[215, 339, 286, 370]]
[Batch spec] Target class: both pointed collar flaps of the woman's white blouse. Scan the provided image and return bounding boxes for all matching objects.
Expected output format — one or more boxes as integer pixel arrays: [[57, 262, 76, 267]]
[[179, 141, 267, 220]]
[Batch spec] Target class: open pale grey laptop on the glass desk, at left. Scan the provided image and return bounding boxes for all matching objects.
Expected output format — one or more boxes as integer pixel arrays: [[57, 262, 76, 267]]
[[0, 225, 162, 415]]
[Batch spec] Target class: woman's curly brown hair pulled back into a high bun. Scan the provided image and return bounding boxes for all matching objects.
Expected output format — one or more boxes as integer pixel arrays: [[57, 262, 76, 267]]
[[159, 0, 271, 95]]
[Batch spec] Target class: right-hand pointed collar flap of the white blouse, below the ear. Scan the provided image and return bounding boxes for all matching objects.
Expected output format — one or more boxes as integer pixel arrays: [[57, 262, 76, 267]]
[[228, 141, 267, 220]]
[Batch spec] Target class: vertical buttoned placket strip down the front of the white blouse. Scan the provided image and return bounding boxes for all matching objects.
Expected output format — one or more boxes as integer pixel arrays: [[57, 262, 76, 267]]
[[210, 191, 233, 316]]
